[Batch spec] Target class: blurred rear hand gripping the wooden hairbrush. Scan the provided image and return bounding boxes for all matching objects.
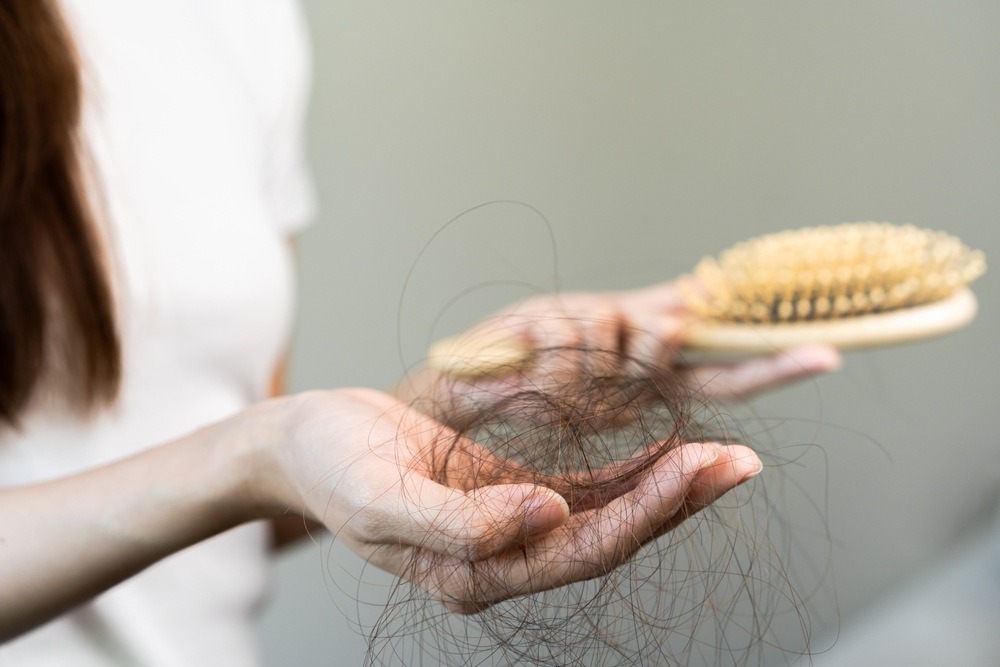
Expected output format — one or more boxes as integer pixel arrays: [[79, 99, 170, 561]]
[[398, 282, 840, 423]]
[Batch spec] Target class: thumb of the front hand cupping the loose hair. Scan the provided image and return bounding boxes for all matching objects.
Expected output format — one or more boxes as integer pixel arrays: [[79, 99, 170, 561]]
[[365, 475, 569, 561]]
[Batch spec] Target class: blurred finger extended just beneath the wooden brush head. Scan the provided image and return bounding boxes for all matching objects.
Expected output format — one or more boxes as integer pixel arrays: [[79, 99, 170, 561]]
[[684, 345, 841, 399]]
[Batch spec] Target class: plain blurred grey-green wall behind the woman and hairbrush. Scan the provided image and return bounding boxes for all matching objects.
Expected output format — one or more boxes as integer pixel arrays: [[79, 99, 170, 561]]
[[263, 0, 1000, 666]]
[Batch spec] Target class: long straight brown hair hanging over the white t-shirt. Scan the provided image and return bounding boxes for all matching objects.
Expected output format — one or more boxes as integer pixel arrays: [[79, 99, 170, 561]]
[[0, 0, 121, 424]]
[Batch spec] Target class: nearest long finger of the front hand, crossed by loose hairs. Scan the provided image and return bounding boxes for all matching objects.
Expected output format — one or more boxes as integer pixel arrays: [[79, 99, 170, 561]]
[[423, 444, 720, 613]]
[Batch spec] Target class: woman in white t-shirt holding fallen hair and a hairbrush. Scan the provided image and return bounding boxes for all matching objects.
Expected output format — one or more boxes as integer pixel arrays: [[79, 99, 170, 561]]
[[0, 0, 836, 665]]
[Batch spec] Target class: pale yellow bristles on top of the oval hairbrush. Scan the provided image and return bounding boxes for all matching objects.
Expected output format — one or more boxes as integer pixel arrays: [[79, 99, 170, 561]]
[[684, 222, 986, 324]]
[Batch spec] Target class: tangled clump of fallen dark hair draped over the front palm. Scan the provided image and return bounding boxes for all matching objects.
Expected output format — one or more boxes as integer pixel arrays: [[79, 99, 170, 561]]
[[367, 348, 808, 666]]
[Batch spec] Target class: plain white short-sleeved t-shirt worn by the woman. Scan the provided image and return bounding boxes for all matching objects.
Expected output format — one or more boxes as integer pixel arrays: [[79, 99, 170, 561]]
[[0, 0, 313, 667]]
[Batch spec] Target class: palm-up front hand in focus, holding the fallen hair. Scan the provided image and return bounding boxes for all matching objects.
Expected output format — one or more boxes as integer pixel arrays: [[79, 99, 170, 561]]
[[248, 390, 760, 613]]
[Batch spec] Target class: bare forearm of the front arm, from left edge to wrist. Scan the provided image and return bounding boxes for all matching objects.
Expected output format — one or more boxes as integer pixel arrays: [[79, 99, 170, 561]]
[[0, 408, 267, 641]]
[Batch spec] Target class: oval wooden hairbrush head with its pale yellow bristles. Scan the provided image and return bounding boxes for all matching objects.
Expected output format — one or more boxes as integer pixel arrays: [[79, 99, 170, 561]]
[[681, 222, 986, 353]]
